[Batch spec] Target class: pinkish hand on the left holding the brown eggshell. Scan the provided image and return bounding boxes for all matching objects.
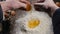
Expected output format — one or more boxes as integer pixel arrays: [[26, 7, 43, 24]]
[[1, 0, 29, 11]]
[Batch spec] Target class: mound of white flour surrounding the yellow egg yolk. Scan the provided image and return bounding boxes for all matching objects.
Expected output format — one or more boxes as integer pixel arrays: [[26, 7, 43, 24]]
[[11, 4, 53, 34]]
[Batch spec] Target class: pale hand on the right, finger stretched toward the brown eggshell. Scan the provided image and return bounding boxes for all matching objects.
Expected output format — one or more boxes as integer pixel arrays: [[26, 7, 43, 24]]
[[35, 0, 58, 10]]
